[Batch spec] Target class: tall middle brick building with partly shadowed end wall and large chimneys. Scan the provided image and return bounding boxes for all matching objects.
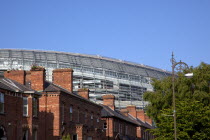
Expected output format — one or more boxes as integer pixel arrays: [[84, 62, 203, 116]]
[[5, 67, 103, 140]]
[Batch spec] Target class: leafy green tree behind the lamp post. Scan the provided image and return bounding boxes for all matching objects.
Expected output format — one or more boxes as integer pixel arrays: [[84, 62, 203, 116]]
[[144, 63, 210, 140]]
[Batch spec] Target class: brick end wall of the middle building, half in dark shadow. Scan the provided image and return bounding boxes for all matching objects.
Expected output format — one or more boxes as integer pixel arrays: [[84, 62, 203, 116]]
[[39, 93, 61, 140]]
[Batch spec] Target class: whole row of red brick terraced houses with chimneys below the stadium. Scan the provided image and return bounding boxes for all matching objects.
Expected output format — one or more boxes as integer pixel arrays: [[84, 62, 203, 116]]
[[0, 66, 152, 140]]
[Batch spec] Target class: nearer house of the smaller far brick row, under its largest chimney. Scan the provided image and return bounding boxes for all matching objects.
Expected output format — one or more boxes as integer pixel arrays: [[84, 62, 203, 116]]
[[102, 94, 138, 140]]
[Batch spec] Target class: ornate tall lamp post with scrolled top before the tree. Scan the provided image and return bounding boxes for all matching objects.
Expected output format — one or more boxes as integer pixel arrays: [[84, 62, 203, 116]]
[[171, 53, 189, 140]]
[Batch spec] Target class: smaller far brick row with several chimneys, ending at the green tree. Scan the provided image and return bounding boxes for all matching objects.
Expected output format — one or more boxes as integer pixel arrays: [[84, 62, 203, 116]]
[[102, 94, 154, 140]]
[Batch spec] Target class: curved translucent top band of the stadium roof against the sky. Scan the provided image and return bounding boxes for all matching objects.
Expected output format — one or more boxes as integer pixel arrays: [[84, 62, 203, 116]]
[[0, 49, 171, 79]]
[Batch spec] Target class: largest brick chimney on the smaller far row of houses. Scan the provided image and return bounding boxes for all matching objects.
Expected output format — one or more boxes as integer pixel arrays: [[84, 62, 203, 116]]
[[102, 94, 115, 110]]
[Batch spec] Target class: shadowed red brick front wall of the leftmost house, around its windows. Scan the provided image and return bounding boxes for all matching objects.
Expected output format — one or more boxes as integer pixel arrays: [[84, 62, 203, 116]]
[[0, 89, 38, 140]]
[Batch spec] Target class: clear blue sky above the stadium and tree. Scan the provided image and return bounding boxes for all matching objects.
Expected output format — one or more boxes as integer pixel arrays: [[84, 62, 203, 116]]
[[0, 0, 210, 71]]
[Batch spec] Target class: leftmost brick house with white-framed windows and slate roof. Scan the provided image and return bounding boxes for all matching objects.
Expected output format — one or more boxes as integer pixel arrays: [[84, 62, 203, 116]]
[[0, 76, 41, 140]]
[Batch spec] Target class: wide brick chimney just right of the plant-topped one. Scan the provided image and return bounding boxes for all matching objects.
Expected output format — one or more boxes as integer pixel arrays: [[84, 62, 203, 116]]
[[53, 68, 73, 92]]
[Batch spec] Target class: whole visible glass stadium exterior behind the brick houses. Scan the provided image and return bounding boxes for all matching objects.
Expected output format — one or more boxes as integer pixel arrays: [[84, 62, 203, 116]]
[[0, 49, 171, 108]]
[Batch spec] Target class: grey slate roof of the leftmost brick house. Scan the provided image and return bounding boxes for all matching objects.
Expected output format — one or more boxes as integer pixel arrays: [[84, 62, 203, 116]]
[[0, 78, 41, 95]]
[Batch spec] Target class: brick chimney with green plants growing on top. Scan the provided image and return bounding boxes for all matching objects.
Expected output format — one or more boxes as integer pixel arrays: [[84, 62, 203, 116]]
[[30, 66, 45, 91]]
